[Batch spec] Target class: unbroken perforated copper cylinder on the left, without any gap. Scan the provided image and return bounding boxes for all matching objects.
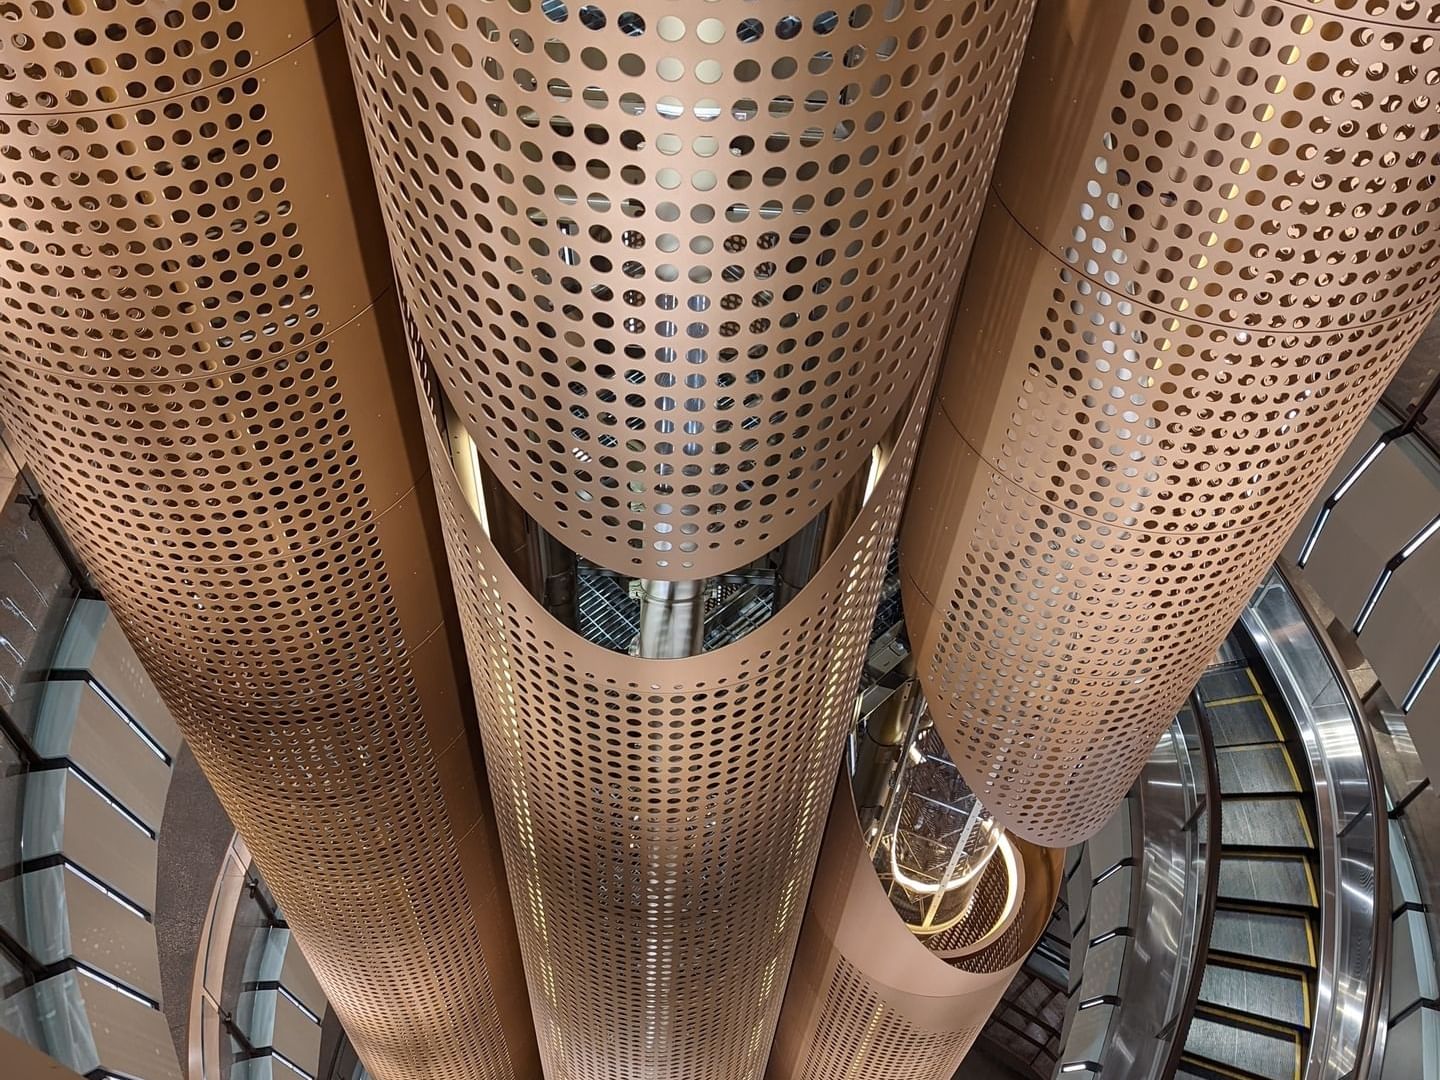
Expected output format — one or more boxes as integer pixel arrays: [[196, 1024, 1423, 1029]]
[[0, 8, 539, 1080]]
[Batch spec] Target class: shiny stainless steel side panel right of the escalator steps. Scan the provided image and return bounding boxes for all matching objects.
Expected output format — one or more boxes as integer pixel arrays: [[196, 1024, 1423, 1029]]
[[1241, 570, 1390, 1080]]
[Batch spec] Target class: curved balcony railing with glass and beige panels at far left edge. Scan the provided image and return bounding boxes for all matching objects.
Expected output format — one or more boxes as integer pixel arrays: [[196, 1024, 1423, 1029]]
[[0, 457, 192, 1080]]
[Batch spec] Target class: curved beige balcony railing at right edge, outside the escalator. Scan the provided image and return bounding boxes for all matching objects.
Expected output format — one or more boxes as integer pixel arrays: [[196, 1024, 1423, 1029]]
[[1286, 318, 1440, 1080]]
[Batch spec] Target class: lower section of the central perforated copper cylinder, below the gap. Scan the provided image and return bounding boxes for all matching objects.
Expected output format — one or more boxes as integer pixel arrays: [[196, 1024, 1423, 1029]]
[[431, 365, 927, 1080]]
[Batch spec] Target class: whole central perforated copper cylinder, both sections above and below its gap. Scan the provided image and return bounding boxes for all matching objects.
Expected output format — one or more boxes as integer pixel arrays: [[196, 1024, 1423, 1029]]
[[343, 0, 1030, 1080]]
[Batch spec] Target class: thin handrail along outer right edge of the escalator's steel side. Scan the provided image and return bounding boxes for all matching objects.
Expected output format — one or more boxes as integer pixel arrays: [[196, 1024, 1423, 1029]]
[[1274, 563, 1392, 1080]]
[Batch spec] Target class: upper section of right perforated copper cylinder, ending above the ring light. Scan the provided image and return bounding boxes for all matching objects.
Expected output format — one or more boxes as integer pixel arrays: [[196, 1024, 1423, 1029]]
[[901, 0, 1440, 845]]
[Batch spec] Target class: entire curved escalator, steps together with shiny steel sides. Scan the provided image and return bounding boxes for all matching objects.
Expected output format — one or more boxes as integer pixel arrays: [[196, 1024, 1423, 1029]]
[[962, 572, 1388, 1080]]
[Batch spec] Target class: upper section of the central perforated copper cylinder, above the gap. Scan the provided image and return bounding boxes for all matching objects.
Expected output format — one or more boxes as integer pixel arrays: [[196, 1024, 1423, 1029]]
[[341, 0, 1031, 580]]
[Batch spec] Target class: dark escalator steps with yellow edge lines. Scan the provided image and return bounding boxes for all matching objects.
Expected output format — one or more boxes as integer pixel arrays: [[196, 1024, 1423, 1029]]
[[1176, 635, 1320, 1080]]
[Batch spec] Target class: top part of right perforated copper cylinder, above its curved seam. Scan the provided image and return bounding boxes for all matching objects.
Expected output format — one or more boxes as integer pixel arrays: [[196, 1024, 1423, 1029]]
[[995, 0, 1440, 333]]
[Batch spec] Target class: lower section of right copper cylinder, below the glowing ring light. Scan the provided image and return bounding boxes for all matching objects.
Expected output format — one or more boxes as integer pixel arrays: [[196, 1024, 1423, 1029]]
[[766, 779, 1063, 1080]]
